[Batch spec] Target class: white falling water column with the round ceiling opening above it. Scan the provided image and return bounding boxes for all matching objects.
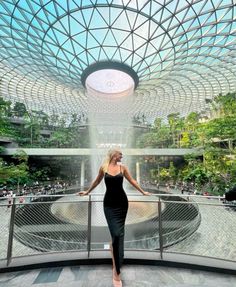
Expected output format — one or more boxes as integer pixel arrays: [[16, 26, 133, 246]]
[[85, 69, 135, 179]]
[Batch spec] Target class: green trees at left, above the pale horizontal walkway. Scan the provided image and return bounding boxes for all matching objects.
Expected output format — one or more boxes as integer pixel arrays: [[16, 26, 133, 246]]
[[0, 98, 88, 148]]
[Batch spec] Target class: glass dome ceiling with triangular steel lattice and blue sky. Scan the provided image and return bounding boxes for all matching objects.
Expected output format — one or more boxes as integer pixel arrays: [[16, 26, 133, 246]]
[[0, 0, 236, 121]]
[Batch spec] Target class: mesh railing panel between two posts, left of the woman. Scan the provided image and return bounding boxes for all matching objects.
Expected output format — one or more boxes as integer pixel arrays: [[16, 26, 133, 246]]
[[12, 197, 88, 257]]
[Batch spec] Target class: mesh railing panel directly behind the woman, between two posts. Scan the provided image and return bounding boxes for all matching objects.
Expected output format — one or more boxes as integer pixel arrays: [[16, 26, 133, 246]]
[[91, 196, 159, 250]]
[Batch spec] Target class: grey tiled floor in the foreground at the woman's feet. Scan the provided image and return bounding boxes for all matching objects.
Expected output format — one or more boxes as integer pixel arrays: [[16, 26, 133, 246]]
[[0, 265, 236, 287]]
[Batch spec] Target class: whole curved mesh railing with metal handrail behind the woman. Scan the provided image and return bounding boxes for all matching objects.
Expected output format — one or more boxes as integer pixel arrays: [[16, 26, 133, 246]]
[[0, 193, 236, 272]]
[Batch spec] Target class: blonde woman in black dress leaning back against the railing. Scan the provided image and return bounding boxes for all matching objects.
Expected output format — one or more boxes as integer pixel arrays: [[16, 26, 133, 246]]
[[78, 149, 151, 287]]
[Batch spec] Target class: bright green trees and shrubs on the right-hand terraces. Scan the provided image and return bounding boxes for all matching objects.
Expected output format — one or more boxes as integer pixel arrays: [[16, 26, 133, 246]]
[[137, 93, 236, 194]]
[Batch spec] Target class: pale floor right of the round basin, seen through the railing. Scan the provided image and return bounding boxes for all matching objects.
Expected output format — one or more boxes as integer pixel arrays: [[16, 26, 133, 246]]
[[166, 197, 236, 261]]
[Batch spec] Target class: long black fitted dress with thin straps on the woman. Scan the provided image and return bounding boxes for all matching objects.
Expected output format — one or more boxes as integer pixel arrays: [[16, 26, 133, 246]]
[[103, 169, 128, 274]]
